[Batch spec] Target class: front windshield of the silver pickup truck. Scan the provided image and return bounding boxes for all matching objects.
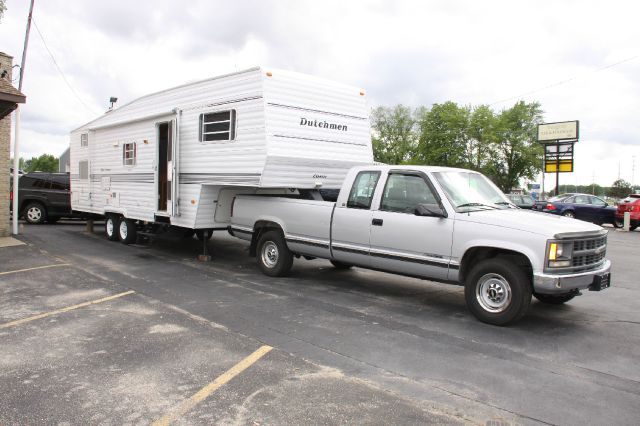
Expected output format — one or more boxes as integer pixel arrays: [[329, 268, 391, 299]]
[[434, 171, 515, 212]]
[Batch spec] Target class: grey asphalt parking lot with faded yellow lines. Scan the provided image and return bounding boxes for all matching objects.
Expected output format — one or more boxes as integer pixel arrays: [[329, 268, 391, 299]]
[[0, 222, 640, 425]]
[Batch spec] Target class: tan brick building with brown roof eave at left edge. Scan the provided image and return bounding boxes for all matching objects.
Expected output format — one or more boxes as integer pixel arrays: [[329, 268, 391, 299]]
[[0, 52, 25, 237]]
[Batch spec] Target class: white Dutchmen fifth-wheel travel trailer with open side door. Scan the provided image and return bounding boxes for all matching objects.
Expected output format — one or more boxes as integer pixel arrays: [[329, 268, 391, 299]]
[[70, 67, 373, 243]]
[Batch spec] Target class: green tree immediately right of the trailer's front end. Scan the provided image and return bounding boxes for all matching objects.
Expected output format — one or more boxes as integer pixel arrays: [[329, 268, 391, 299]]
[[371, 105, 416, 164]]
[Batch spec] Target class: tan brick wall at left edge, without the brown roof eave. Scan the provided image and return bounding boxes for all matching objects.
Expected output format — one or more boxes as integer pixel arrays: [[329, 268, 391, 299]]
[[0, 52, 13, 237]]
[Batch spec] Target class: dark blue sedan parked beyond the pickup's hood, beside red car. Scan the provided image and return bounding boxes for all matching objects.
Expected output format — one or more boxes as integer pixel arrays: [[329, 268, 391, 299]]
[[535, 194, 617, 225]]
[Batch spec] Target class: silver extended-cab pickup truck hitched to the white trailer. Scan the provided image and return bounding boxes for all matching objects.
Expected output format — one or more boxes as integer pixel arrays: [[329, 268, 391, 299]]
[[229, 166, 611, 325]]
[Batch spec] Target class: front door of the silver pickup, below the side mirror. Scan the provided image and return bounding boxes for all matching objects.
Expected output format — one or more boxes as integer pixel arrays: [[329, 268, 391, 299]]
[[370, 170, 454, 279]]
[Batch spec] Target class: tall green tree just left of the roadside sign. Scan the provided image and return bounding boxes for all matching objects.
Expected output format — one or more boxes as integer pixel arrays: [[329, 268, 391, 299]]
[[484, 101, 543, 192]]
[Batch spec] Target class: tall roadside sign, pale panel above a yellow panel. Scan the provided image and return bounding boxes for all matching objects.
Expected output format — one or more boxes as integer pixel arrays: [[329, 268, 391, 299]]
[[538, 120, 580, 195]]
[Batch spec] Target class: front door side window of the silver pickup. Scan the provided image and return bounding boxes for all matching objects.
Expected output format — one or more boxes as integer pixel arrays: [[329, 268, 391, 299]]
[[380, 173, 438, 213]]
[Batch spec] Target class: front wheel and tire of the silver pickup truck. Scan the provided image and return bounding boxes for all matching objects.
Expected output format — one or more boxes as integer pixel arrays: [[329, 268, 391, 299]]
[[464, 258, 532, 326]]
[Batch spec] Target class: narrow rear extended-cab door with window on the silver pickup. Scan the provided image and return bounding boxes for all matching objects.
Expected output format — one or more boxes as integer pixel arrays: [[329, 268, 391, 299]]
[[331, 170, 380, 266]]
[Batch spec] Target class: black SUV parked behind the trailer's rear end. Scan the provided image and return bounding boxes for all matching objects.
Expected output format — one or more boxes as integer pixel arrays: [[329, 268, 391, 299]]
[[11, 172, 78, 223]]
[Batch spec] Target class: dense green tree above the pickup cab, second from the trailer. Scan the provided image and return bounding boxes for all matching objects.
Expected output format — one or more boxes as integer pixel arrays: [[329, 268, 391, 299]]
[[414, 101, 470, 167]]
